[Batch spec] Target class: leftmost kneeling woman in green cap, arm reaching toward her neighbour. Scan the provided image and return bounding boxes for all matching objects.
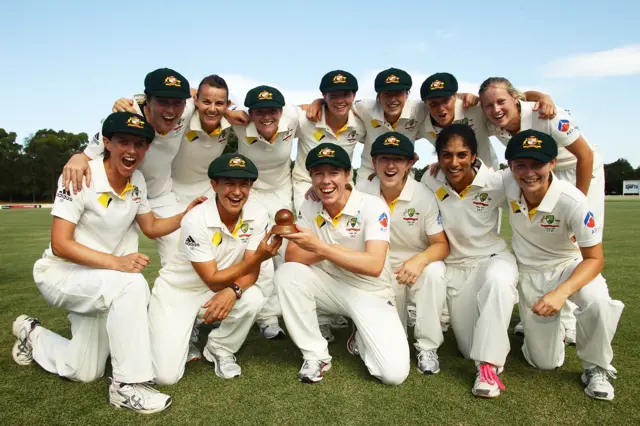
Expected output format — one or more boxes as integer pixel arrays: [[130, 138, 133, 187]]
[[13, 112, 202, 413]]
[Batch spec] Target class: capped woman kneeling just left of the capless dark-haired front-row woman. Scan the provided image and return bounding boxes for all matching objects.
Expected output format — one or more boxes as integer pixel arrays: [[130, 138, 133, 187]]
[[357, 132, 449, 374]]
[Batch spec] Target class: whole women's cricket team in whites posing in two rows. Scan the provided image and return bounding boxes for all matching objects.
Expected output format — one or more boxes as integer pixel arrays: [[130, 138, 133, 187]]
[[13, 68, 624, 413]]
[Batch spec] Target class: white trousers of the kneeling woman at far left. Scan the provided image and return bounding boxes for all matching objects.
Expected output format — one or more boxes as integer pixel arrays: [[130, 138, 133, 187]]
[[31, 261, 153, 383]]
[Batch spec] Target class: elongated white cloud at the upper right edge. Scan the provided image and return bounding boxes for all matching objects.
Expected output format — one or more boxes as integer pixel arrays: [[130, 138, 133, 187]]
[[546, 44, 640, 77]]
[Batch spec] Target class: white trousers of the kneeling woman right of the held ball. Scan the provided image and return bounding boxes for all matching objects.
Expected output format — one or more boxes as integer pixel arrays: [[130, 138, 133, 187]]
[[275, 262, 410, 385]]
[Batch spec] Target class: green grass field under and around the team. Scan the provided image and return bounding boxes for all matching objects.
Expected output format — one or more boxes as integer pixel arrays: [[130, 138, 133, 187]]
[[0, 200, 640, 425]]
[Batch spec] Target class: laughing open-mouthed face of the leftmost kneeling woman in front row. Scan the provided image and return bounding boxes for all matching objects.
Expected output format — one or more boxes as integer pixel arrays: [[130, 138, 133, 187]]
[[103, 133, 149, 178]]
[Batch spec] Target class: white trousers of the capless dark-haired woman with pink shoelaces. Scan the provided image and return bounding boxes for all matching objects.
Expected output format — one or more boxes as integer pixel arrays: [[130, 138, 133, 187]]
[[444, 251, 518, 367]]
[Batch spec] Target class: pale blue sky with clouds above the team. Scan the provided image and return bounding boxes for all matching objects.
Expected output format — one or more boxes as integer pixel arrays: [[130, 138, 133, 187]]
[[0, 0, 640, 167]]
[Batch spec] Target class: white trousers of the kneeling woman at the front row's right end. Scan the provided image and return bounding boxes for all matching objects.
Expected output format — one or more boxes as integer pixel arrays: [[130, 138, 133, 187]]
[[519, 259, 624, 370]]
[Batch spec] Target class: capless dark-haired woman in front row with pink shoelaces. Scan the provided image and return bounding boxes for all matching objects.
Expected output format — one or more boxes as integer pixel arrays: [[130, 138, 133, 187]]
[[422, 124, 518, 398]]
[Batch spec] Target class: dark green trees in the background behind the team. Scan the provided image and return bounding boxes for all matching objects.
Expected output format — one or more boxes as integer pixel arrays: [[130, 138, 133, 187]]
[[0, 128, 640, 203]]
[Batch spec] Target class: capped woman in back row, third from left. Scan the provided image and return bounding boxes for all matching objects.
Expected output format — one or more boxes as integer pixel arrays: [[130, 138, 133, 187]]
[[233, 86, 301, 339]]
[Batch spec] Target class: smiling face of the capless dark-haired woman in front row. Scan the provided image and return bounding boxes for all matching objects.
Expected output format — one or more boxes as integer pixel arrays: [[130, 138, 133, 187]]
[[438, 135, 476, 190]]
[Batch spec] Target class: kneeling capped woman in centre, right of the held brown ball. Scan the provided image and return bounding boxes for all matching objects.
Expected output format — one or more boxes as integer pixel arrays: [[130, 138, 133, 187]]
[[275, 143, 410, 385]]
